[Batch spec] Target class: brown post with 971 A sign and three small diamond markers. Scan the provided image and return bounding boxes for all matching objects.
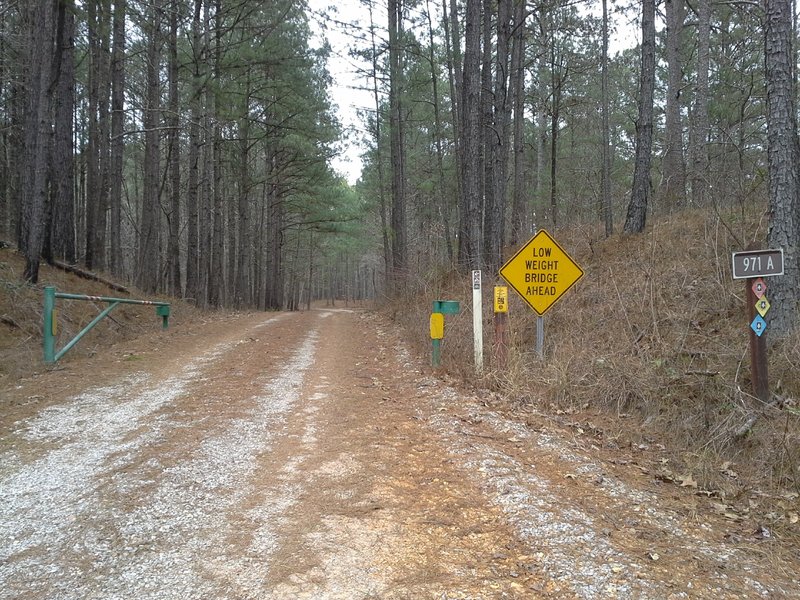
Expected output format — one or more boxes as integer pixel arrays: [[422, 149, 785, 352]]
[[731, 248, 783, 402]]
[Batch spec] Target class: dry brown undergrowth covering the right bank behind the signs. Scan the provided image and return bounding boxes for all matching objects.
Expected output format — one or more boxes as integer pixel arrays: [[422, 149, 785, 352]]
[[394, 212, 800, 544]]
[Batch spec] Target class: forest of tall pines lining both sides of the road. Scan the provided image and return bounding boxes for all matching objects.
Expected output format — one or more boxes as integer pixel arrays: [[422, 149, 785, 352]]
[[0, 0, 800, 328]]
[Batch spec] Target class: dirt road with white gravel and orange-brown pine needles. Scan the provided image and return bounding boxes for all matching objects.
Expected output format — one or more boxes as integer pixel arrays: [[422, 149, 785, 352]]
[[0, 310, 800, 600]]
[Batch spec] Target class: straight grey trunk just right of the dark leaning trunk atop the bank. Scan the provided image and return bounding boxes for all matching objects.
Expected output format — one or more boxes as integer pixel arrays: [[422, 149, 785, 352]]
[[659, 0, 686, 210]]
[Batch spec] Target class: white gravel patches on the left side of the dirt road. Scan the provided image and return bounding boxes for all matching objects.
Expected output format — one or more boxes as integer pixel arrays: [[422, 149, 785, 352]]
[[0, 324, 317, 600]]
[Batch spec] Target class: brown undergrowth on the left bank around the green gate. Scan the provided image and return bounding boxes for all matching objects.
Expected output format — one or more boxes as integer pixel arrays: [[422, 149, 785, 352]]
[[0, 248, 199, 387]]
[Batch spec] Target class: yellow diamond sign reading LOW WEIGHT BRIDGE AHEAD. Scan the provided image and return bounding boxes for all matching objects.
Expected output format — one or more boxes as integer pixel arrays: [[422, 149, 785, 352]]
[[500, 229, 583, 315]]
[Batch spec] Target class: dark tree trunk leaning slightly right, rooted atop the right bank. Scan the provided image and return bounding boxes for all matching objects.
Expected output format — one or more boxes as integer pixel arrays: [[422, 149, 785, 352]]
[[624, 0, 656, 233]]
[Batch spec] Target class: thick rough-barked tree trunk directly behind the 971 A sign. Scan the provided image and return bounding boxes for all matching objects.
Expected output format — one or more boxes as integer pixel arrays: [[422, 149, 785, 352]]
[[764, 0, 800, 337]]
